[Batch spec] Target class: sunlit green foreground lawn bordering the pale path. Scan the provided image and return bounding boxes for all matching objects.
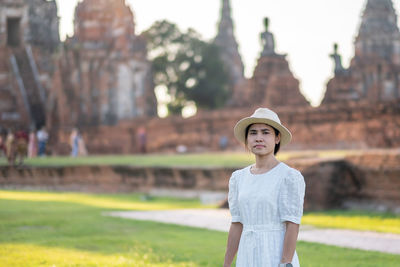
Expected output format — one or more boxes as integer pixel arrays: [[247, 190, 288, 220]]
[[0, 191, 400, 267]]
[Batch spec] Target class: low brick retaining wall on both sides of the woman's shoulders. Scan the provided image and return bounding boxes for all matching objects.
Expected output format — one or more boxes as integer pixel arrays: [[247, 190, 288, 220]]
[[0, 150, 400, 212]]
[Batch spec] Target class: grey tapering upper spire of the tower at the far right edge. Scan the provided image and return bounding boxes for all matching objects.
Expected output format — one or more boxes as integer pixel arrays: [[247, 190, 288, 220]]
[[355, 0, 400, 60]]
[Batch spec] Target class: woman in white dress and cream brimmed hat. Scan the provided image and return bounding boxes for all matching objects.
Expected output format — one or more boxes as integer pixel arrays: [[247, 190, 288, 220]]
[[224, 108, 305, 267]]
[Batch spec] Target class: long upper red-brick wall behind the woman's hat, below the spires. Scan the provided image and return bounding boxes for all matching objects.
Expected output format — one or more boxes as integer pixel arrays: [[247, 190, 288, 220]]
[[50, 102, 400, 154]]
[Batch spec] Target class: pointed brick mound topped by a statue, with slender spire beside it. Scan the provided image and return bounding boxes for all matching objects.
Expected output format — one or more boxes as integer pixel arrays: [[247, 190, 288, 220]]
[[214, 0, 309, 108]]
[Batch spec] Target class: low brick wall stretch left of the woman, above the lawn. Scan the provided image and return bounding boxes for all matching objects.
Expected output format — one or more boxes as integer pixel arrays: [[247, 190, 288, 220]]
[[0, 166, 234, 192]]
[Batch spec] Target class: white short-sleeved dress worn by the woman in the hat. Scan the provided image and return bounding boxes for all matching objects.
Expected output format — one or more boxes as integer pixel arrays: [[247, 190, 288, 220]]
[[228, 162, 305, 267]]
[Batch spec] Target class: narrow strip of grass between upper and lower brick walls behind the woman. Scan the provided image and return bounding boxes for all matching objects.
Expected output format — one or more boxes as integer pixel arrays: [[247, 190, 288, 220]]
[[0, 150, 359, 168]]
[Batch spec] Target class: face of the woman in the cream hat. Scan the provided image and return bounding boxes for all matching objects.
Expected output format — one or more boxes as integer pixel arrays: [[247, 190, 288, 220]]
[[247, 123, 280, 156]]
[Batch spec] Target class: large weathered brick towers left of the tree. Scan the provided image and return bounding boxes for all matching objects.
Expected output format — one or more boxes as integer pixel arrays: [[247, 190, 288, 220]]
[[0, 0, 157, 133]]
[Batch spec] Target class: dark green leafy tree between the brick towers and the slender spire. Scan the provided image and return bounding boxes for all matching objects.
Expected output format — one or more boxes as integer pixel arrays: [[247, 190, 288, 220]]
[[144, 20, 230, 114]]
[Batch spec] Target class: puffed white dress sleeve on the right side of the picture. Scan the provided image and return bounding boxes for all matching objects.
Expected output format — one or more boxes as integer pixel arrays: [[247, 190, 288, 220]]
[[279, 169, 306, 224]]
